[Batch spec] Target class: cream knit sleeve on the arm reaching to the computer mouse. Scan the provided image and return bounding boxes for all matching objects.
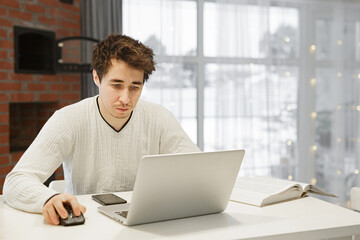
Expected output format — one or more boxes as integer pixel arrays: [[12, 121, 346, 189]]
[[3, 111, 74, 213]]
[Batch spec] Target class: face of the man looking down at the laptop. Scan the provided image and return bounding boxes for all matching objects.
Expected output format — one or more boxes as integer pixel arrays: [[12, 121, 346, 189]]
[[93, 60, 144, 125]]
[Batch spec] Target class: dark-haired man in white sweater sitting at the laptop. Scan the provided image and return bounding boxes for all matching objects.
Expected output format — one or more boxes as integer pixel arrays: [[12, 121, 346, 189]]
[[4, 35, 199, 225]]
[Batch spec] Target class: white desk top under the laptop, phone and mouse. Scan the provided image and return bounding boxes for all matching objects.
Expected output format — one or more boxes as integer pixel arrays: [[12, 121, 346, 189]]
[[0, 192, 360, 240]]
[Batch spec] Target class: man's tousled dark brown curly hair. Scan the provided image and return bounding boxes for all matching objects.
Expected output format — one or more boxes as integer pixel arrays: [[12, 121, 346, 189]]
[[91, 34, 155, 83]]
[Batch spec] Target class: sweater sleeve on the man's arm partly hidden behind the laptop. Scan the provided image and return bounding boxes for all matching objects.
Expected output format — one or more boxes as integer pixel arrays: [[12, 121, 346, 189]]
[[158, 108, 200, 154]]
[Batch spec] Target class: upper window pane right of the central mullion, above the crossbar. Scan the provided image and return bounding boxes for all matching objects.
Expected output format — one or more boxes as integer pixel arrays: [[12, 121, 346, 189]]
[[204, 2, 299, 58]]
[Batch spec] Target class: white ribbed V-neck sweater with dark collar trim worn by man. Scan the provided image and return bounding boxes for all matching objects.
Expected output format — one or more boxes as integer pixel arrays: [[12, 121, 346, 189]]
[[3, 96, 200, 212]]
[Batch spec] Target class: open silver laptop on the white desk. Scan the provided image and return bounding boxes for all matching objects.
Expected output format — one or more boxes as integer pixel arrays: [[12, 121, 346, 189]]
[[98, 150, 245, 226]]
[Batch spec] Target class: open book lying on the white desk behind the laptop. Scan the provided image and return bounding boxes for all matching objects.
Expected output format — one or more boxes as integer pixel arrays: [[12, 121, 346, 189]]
[[230, 177, 336, 207]]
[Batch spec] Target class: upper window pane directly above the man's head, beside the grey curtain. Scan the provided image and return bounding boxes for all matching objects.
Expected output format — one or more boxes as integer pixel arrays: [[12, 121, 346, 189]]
[[123, 0, 197, 56]]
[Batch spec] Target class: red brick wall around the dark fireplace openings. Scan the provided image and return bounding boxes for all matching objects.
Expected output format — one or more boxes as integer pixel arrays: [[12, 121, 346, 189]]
[[0, 0, 81, 194]]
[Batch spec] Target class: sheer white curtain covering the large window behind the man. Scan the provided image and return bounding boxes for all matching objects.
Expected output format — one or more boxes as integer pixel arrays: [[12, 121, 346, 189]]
[[123, 0, 360, 205]]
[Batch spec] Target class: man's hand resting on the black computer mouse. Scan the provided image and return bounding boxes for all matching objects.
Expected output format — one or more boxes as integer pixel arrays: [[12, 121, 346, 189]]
[[42, 193, 86, 225]]
